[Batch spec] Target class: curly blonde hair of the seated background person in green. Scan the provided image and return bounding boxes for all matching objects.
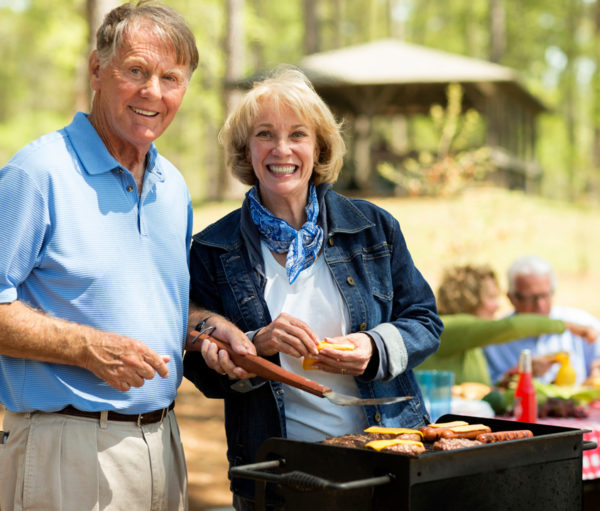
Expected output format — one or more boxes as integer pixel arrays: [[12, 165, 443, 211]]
[[437, 264, 498, 314]]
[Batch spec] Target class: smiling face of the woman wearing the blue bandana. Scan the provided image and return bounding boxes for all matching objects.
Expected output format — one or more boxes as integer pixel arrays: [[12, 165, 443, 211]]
[[248, 101, 317, 209]]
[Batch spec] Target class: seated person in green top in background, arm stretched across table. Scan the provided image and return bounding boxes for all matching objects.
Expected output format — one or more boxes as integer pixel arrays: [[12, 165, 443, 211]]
[[417, 264, 592, 385]]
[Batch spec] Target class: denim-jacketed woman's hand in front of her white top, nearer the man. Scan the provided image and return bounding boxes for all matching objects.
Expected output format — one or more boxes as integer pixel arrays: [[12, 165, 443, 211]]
[[252, 312, 319, 358]]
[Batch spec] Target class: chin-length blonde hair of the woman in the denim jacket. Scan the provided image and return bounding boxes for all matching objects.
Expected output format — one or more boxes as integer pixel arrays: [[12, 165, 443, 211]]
[[219, 67, 346, 186]]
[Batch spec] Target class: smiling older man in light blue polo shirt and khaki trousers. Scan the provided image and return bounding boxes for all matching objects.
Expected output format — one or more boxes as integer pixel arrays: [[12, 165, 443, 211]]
[[0, 3, 251, 511]]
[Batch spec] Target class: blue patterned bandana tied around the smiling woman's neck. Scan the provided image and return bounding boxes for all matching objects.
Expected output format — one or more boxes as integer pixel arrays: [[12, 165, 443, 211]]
[[248, 183, 323, 284]]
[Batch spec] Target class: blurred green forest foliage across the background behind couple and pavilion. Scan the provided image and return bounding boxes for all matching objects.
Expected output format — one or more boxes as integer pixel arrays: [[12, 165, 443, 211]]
[[0, 0, 600, 199]]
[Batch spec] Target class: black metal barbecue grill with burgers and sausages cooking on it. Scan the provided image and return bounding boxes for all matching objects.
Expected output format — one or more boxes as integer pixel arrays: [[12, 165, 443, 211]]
[[231, 414, 596, 511]]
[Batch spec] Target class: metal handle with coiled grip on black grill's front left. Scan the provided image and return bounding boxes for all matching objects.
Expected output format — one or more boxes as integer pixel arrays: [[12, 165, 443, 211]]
[[229, 460, 394, 491]]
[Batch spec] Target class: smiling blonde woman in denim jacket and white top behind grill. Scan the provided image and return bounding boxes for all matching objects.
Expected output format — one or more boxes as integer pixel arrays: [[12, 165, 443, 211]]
[[185, 69, 442, 509]]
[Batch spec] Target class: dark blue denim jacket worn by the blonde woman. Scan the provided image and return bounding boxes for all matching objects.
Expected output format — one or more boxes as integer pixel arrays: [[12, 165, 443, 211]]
[[184, 185, 443, 502]]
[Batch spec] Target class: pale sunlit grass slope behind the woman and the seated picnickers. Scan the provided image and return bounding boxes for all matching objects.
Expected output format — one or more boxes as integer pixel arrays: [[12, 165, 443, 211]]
[[194, 187, 600, 318]]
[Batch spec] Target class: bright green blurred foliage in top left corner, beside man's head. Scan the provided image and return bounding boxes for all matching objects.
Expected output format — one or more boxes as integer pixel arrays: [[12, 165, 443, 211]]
[[0, 0, 87, 162]]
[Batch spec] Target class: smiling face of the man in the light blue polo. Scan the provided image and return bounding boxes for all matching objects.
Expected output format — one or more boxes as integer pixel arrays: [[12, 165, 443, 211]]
[[90, 27, 189, 152]]
